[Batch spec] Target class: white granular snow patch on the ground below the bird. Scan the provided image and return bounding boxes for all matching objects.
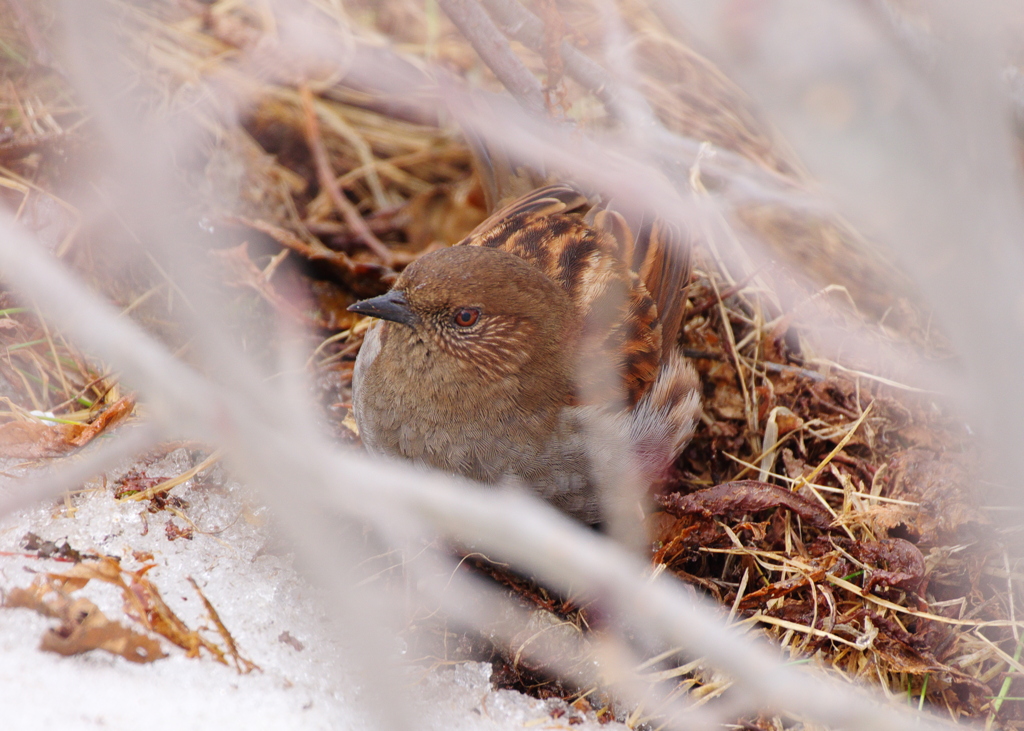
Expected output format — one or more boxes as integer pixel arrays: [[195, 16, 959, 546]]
[[0, 449, 626, 731]]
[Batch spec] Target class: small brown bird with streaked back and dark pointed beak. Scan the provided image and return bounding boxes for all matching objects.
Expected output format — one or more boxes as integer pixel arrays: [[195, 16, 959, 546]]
[[349, 185, 698, 523]]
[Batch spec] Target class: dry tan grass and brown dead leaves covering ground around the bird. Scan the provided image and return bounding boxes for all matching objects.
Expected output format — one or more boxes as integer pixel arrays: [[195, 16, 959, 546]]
[[0, 0, 1024, 728]]
